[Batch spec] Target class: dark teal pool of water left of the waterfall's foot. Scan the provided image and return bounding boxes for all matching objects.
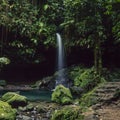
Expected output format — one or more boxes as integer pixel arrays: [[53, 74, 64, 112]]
[[0, 90, 52, 101]]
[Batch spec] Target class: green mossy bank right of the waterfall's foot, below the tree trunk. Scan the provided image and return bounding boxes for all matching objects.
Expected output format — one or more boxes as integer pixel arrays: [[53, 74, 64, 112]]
[[69, 66, 105, 92]]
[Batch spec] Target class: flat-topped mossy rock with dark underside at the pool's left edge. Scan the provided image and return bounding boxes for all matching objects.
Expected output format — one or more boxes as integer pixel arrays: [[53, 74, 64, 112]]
[[1, 92, 27, 108]]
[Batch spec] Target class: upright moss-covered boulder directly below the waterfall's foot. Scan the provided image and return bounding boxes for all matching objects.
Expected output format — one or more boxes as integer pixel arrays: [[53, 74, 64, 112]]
[[52, 85, 73, 104]]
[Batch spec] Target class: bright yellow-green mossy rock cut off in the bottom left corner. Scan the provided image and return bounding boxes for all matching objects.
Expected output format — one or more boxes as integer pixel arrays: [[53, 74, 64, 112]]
[[0, 101, 16, 120]]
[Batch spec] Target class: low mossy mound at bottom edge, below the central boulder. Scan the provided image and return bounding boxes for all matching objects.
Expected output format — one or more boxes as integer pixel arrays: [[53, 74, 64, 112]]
[[51, 105, 84, 120]]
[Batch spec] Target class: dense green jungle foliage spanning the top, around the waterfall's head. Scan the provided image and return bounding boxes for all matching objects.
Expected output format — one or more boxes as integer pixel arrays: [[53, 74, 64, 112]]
[[0, 0, 120, 72]]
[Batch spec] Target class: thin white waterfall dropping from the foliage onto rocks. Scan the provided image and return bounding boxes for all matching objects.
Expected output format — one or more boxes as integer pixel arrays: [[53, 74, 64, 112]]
[[56, 33, 66, 86]]
